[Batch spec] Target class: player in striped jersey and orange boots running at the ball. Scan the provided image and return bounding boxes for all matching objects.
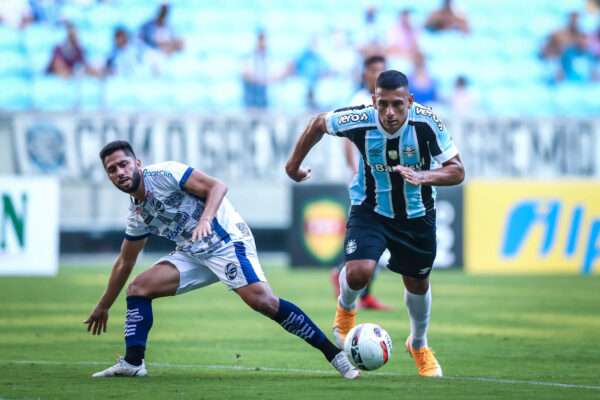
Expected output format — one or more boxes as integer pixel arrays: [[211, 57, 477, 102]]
[[286, 70, 465, 376]]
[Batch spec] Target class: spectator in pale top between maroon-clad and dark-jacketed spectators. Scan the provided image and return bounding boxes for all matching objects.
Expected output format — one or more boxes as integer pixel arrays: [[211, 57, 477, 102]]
[[104, 27, 164, 76]]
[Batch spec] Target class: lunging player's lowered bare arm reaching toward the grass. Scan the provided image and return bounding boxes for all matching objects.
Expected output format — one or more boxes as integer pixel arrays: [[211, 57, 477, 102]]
[[83, 239, 147, 335]]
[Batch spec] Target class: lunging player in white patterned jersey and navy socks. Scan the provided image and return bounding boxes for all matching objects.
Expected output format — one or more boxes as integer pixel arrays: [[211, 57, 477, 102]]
[[84, 140, 360, 379]]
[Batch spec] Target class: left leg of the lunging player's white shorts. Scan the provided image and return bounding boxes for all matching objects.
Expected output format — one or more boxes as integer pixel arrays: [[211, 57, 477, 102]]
[[157, 251, 219, 294]]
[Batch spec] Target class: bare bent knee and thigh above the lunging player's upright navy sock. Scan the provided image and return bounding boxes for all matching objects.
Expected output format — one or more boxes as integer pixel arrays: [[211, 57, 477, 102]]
[[127, 261, 179, 299]]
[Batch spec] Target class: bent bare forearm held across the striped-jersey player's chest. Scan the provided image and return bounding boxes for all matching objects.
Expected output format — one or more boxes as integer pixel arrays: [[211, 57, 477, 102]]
[[392, 154, 465, 186]]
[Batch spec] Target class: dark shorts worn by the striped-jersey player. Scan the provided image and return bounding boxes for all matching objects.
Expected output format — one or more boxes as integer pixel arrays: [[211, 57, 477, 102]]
[[344, 206, 437, 279]]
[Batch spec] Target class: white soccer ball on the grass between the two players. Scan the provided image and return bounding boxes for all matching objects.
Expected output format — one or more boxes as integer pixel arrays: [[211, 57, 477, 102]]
[[344, 323, 392, 371]]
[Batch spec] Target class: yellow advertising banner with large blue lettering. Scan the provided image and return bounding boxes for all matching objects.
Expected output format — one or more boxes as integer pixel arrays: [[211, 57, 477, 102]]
[[465, 181, 600, 274]]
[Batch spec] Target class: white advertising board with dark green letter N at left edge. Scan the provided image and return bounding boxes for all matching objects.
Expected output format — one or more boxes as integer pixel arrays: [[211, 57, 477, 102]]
[[0, 176, 59, 275]]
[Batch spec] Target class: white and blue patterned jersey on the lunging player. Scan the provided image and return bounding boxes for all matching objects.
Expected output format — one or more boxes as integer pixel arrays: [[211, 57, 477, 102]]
[[125, 161, 252, 254]]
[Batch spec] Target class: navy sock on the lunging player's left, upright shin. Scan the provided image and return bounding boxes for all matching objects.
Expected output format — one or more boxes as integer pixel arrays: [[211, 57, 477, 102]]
[[125, 296, 153, 365]]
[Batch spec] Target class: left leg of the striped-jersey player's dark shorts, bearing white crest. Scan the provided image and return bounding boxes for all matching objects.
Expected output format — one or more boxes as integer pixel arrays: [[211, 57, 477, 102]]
[[344, 206, 387, 264]]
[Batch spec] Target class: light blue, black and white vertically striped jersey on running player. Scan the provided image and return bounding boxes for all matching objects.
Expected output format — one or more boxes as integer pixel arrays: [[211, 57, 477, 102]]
[[325, 103, 458, 218]]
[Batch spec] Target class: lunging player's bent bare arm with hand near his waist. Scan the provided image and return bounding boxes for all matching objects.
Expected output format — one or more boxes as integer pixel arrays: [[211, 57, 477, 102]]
[[185, 170, 227, 243]]
